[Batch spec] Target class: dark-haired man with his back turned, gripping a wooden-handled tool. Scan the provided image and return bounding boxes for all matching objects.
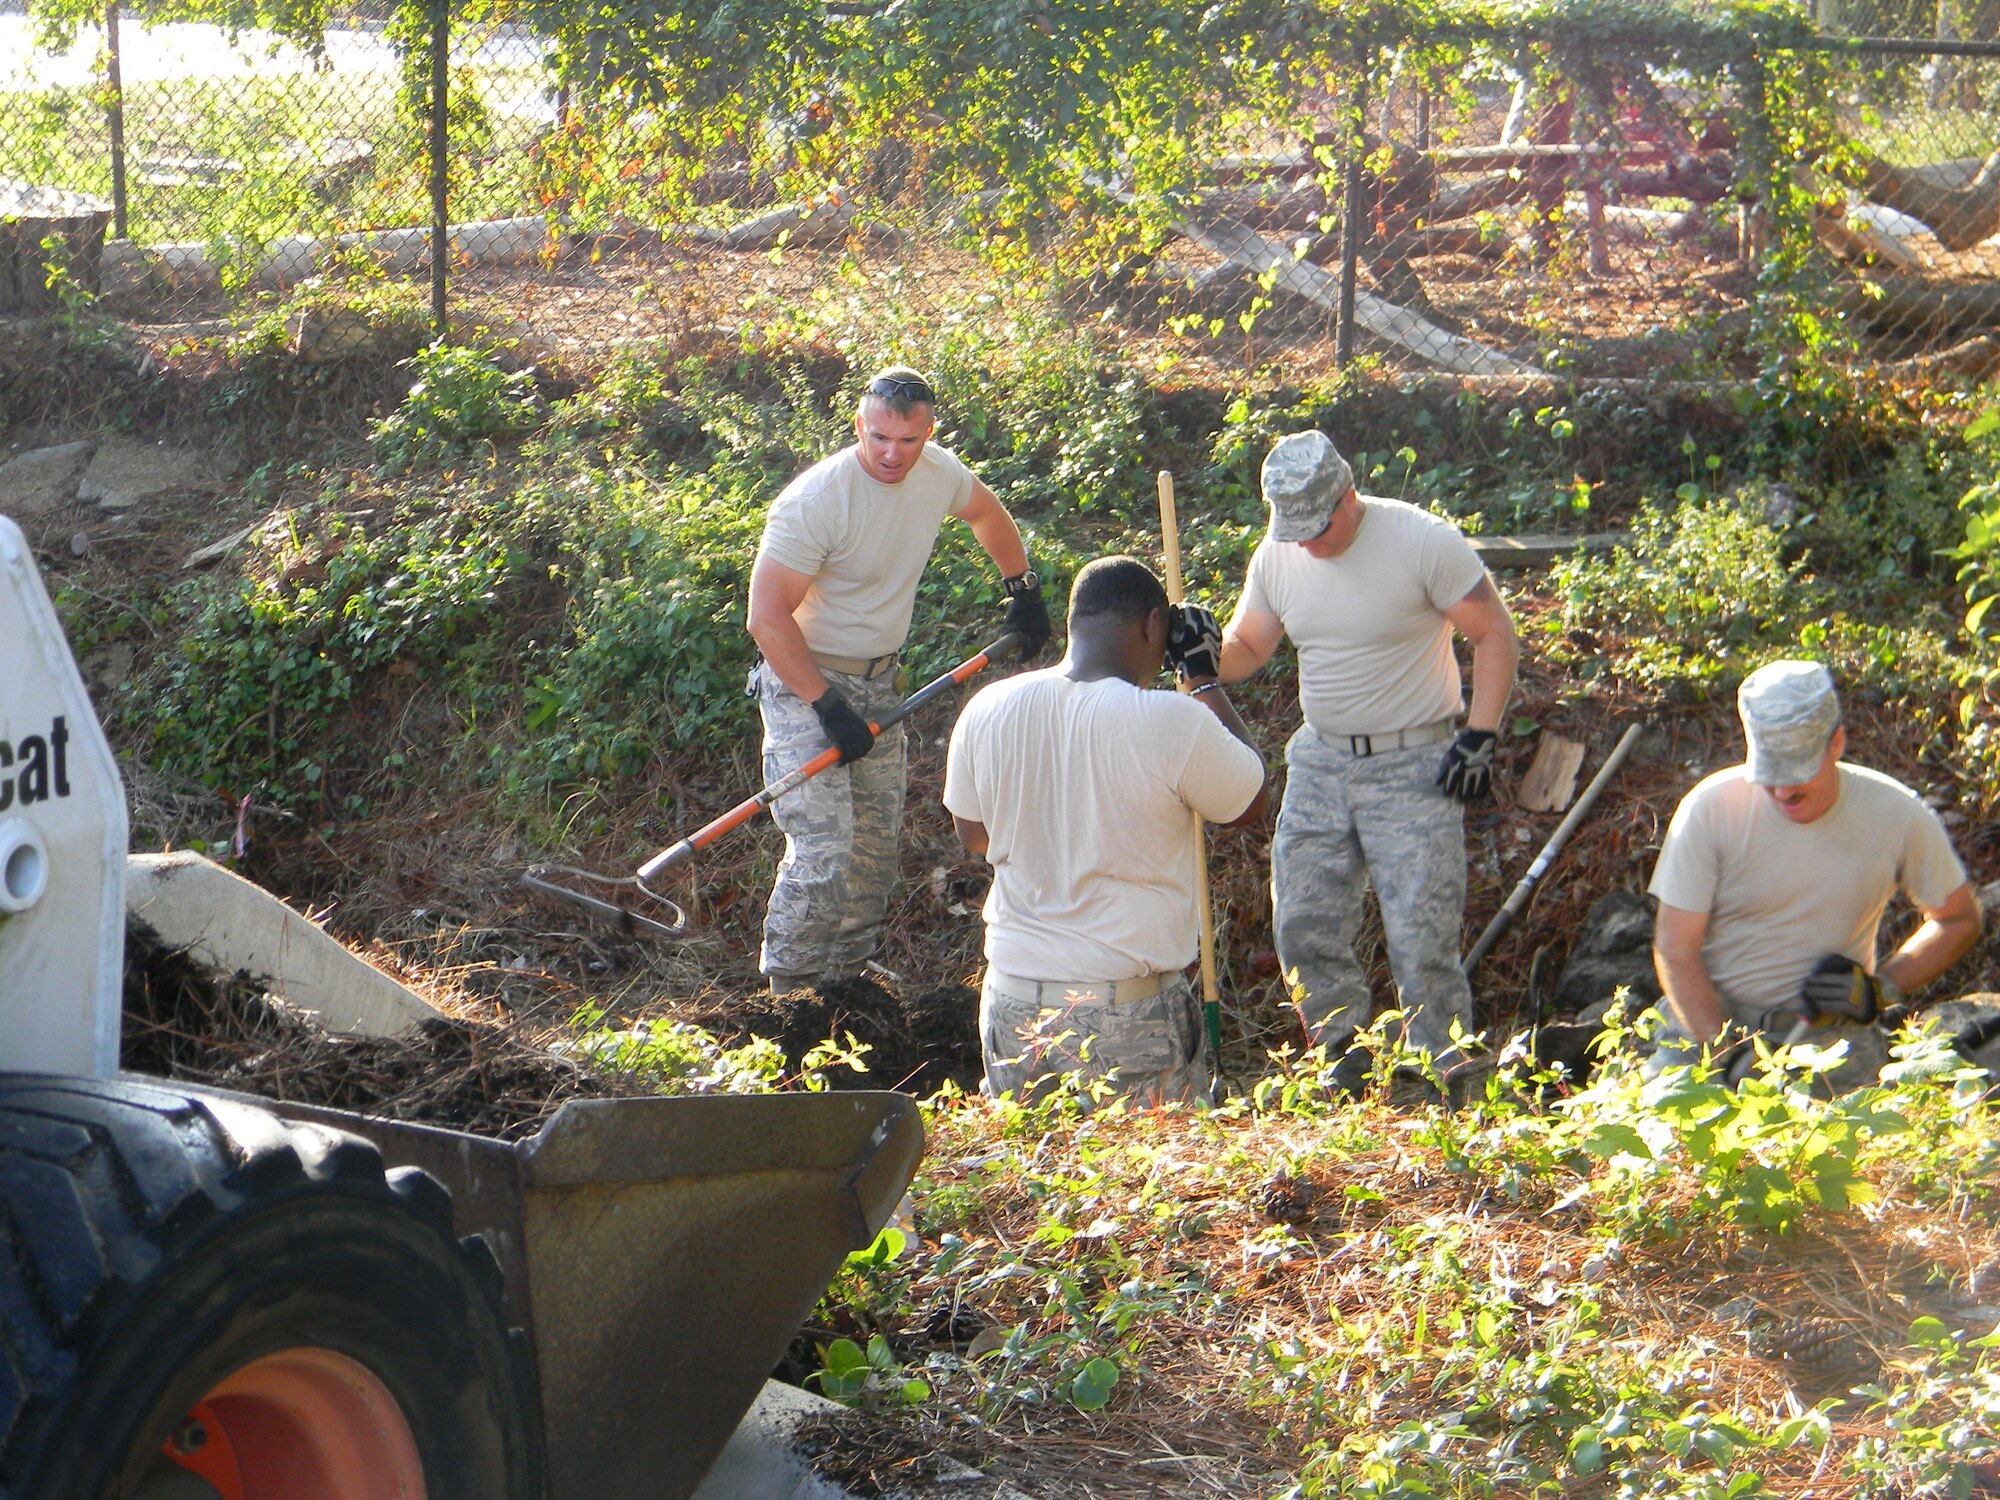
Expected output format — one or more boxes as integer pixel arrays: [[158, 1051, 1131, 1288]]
[[944, 558, 1266, 1104]]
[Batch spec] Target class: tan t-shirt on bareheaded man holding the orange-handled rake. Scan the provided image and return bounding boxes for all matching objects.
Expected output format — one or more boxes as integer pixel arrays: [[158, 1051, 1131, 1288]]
[[758, 442, 972, 656]]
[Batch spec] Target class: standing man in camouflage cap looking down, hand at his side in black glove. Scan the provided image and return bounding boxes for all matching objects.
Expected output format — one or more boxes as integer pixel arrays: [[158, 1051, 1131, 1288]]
[[1222, 432, 1520, 1086]]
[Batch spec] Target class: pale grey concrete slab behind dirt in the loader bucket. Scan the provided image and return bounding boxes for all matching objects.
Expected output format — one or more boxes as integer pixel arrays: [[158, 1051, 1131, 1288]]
[[126, 850, 442, 1036]]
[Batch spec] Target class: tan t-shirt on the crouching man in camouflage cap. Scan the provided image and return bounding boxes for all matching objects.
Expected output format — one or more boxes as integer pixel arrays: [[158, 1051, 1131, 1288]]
[[1650, 762, 1966, 1022]]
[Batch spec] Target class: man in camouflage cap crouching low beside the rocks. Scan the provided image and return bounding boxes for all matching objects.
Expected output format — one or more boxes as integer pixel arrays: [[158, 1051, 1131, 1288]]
[[1648, 662, 1980, 1086]]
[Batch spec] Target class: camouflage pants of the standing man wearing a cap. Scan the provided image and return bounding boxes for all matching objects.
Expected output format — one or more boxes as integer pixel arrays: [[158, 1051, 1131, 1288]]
[[1270, 728, 1472, 1058]]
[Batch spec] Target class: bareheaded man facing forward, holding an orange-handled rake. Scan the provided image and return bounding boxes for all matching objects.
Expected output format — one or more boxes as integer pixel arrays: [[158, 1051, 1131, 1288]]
[[750, 366, 1050, 994]]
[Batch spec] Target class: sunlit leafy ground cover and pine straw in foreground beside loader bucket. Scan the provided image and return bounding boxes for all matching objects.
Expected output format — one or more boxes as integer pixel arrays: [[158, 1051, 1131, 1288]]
[[800, 1038, 2000, 1500]]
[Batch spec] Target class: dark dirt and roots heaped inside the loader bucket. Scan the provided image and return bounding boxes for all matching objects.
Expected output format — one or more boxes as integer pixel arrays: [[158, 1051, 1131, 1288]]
[[120, 924, 644, 1140]]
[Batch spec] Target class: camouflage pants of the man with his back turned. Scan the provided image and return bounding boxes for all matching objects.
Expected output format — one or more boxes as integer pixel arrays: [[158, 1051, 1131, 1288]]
[[980, 970, 1214, 1108]]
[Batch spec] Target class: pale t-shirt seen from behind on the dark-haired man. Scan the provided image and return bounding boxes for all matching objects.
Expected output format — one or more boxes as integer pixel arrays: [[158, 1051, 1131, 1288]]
[[944, 666, 1264, 980]]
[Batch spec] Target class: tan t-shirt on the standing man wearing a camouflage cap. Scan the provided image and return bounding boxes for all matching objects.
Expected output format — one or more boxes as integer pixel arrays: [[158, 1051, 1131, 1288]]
[[1242, 494, 1486, 740]]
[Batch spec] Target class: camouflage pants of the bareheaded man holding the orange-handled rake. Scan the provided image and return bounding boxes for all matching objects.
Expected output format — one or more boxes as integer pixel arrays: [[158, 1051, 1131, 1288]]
[[752, 666, 904, 980]]
